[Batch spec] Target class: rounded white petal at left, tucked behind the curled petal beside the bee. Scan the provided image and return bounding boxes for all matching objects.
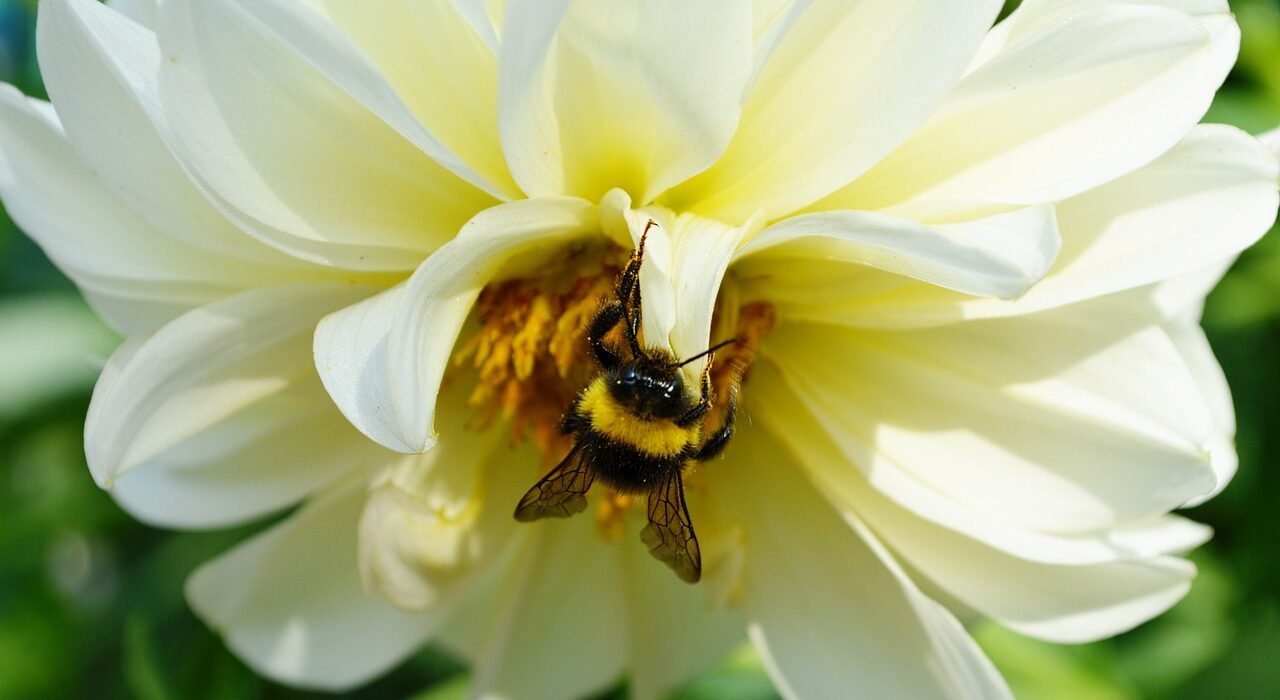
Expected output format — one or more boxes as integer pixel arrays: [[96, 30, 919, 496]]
[[84, 283, 373, 527]]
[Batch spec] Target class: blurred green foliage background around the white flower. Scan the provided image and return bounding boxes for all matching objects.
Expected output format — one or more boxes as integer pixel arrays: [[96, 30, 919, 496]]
[[0, 0, 1280, 700]]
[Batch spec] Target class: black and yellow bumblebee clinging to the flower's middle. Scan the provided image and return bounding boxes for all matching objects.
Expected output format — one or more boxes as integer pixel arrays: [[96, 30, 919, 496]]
[[516, 220, 737, 584]]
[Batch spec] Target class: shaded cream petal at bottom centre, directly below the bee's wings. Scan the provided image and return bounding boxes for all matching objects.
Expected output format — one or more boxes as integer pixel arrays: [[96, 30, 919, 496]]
[[433, 499, 744, 699]]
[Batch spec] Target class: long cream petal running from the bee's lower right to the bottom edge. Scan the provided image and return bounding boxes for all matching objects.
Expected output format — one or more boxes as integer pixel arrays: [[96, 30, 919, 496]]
[[707, 430, 1009, 699]]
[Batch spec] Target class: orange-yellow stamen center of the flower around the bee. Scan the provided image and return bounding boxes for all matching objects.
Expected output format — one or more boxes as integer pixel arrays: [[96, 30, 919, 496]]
[[453, 238, 776, 539]]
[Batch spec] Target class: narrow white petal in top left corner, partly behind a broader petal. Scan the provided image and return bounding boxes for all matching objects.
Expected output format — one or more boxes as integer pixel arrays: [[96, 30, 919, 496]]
[[37, 0, 301, 267]]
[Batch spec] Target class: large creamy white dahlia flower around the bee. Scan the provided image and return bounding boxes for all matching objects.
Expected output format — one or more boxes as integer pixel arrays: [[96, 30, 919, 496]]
[[0, 0, 1280, 697]]
